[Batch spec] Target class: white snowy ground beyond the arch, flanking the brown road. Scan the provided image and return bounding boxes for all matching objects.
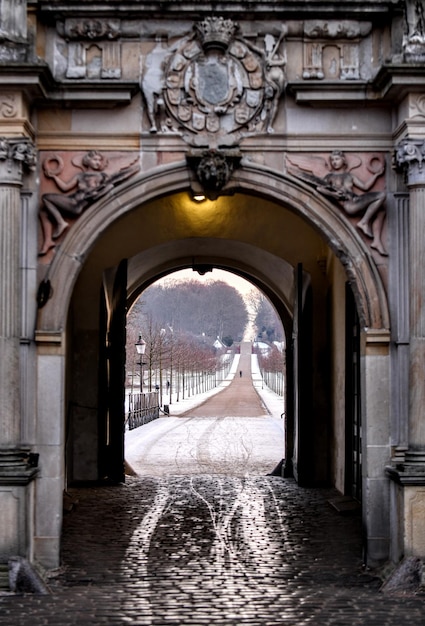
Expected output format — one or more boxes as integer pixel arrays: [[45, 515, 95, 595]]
[[125, 355, 284, 476]]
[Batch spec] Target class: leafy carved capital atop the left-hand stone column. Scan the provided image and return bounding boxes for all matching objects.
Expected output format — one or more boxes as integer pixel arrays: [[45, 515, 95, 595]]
[[0, 137, 36, 185]]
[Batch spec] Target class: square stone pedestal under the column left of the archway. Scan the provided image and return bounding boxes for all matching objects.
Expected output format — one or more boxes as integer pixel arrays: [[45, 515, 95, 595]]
[[0, 448, 38, 562]]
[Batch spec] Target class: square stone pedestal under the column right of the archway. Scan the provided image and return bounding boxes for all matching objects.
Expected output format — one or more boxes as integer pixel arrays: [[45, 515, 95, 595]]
[[386, 450, 425, 560]]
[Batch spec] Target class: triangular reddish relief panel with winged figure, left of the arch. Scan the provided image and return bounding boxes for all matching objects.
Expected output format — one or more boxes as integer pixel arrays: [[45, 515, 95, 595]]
[[39, 150, 140, 256]]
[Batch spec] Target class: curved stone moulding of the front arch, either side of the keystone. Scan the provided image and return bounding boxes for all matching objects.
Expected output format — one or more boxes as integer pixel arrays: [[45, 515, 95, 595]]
[[37, 162, 389, 331]]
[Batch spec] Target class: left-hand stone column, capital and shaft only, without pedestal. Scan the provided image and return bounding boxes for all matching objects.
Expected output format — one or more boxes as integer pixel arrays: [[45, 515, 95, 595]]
[[0, 137, 35, 447]]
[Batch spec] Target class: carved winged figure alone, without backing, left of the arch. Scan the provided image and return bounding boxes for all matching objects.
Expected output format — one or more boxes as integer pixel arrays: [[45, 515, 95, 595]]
[[39, 150, 139, 256]]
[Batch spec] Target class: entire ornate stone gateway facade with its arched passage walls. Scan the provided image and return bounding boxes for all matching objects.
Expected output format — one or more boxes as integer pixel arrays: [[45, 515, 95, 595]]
[[0, 0, 425, 567]]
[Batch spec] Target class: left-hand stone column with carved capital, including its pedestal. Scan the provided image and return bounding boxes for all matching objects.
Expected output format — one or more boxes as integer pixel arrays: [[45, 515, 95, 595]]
[[0, 137, 37, 560]]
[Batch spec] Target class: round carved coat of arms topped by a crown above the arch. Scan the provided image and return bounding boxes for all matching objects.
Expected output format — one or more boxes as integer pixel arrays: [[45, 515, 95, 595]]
[[141, 17, 286, 147]]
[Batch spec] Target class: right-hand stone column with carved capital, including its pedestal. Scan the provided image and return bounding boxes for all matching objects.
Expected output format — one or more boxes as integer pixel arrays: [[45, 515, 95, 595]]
[[388, 139, 425, 558]]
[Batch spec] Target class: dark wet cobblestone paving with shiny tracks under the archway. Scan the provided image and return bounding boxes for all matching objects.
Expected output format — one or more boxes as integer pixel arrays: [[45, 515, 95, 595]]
[[0, 475, 425, 626]]
